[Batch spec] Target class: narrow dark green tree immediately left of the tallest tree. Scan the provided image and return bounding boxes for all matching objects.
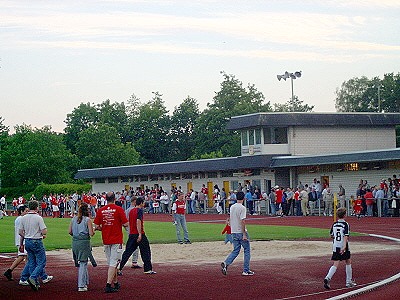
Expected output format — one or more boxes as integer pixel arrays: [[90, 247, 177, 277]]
[[170, 96, 200, 161]]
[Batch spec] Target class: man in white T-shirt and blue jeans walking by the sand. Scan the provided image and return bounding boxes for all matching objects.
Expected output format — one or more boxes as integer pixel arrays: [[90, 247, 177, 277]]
[[221, 192, 254, 276]]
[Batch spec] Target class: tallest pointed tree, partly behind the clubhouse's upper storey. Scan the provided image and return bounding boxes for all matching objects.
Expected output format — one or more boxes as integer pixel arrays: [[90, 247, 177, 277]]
[[194, 72, 272, 157]]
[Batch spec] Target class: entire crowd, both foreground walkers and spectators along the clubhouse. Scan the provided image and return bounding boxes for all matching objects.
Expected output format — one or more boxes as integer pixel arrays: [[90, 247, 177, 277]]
[[7, 175, 400, 293]]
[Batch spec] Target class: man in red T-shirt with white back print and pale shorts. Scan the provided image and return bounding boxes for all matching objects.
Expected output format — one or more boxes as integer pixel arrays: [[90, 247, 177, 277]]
[[94, 192, 129, 293]]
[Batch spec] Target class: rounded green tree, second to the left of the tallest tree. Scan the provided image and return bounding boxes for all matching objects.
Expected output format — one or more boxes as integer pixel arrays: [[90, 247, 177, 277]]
[[130, 92, 171, 163]]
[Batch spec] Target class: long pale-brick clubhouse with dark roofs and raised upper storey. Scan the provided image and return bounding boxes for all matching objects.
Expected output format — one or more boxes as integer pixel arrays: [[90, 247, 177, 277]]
[[75, 112, 400, 203]]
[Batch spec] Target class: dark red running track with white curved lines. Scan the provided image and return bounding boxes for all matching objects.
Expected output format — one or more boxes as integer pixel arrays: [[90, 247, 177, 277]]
[[0, 214, 400, 300]]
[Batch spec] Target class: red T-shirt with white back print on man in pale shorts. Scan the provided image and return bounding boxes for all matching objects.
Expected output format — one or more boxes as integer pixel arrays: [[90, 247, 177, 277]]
[[94, 203, 128, 245]]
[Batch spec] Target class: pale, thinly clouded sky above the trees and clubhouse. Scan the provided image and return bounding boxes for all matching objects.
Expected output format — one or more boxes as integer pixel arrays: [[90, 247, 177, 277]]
[[0, 0, 400, 132]]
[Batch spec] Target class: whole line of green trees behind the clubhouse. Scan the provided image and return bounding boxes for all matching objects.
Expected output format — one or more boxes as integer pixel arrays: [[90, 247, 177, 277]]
[[0, 72, 400, 196]]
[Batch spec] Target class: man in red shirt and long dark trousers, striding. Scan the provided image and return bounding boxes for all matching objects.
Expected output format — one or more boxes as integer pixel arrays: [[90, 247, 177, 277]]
[[119, 197, 156, 275]]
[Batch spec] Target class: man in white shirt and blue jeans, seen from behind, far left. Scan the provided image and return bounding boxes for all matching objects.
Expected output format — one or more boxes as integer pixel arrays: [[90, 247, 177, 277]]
[[19, 200, 47, 291]]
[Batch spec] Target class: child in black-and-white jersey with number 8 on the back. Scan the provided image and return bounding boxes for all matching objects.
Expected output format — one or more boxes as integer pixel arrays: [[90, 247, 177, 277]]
[[324, 207, 357, 290]]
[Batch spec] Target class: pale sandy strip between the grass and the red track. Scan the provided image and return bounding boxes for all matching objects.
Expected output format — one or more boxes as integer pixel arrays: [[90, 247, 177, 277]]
[[47, 241, 400, 264]]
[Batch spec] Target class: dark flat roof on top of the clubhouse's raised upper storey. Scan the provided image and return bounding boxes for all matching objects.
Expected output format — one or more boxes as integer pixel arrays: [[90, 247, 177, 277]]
[[227, 112, 400, 130]]
